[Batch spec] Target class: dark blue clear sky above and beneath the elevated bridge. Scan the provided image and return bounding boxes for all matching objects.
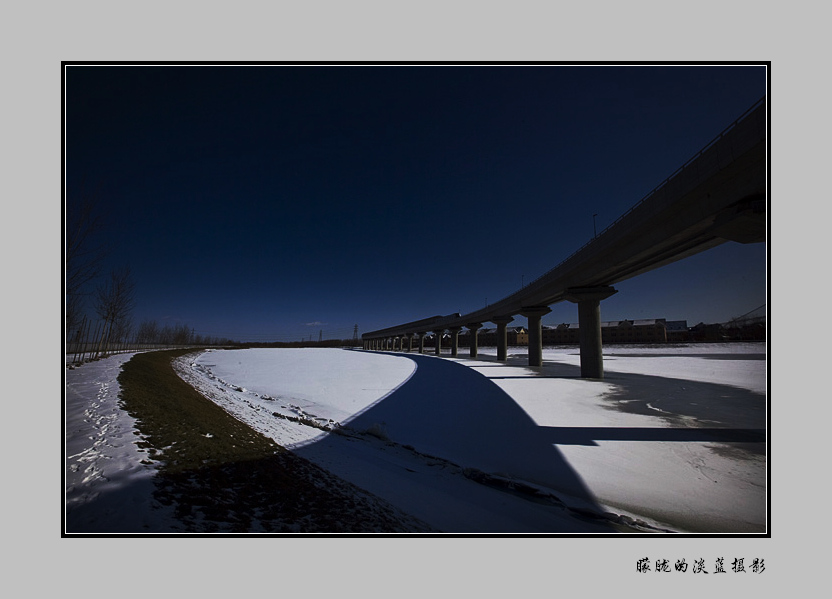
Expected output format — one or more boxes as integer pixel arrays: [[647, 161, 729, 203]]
[[65, 65, 767, 341]]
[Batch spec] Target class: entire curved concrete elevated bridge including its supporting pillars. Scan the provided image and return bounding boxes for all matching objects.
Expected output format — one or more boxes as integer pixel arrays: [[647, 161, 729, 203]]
[[362, 97, 768, 379]]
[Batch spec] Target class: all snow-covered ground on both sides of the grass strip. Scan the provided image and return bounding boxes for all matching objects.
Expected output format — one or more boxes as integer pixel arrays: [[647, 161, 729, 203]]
[[66, 343, 767, 533]]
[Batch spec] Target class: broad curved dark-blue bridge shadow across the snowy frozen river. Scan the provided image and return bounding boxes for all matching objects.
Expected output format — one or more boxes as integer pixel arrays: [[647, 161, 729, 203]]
[[292, 352, 620, 533]]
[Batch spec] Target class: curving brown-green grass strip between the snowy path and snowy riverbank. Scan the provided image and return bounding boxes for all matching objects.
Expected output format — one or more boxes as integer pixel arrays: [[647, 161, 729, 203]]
[[118, 350, 438, 533]]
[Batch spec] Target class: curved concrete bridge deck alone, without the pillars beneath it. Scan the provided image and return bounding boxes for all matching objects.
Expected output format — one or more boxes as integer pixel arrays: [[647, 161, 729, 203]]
[[362, 99, 767, 339]]
